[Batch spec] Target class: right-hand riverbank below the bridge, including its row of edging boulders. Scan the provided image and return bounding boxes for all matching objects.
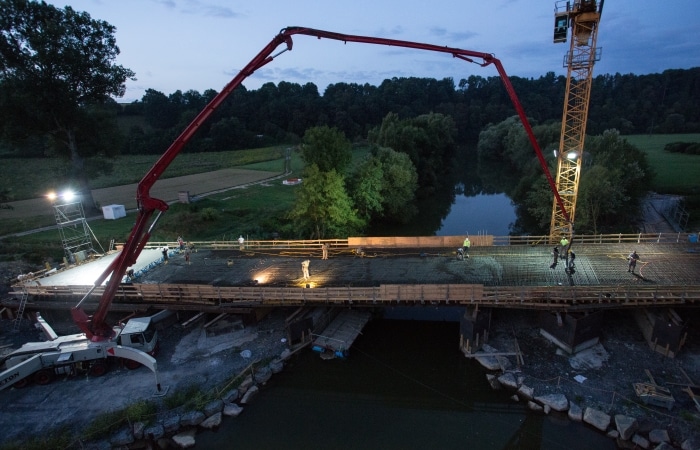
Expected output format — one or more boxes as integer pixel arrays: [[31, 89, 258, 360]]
[[480, 311, 700, 450]]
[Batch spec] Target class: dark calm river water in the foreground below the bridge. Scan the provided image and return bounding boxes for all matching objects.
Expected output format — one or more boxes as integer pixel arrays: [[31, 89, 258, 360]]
[[196, 319, 615, 450]]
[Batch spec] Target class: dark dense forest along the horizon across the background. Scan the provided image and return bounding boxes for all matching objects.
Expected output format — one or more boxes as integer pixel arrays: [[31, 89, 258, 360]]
[[108, 68, 700, 154]]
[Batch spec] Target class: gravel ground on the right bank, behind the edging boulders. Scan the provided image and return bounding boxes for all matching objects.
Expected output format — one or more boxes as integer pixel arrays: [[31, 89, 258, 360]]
[[489, 310, 700, 447]]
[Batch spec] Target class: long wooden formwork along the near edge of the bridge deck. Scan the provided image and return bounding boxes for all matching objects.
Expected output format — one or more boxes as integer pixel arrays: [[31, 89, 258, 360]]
[[11, 284, 700, 312]]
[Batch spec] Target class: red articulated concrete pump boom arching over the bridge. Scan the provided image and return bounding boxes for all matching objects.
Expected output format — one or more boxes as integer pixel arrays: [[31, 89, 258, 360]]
[[72, 27, 565, 340]]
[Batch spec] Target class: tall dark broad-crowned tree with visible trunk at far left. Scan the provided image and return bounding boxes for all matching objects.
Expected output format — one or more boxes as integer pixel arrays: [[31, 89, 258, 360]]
[[0, 0, 134, 211]]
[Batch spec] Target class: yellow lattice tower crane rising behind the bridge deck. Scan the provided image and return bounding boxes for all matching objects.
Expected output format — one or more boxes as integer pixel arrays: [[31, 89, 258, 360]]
[[549, 0, 604, 246]]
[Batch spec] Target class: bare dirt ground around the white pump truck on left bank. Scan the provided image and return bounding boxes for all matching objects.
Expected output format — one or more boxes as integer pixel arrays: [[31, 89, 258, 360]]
[[0, 310, 287, 448]]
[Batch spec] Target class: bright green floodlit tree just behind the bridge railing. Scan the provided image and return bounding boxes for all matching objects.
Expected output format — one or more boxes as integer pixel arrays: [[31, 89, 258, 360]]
[[289, 164, 365, 239]]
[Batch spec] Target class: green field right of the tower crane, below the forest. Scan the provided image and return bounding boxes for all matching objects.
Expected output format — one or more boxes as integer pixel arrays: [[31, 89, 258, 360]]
[[625, 134, 700, 195]]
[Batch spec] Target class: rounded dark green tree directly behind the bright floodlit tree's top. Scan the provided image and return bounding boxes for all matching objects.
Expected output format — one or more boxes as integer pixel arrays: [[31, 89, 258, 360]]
[[301, 125, 352, 174]]
